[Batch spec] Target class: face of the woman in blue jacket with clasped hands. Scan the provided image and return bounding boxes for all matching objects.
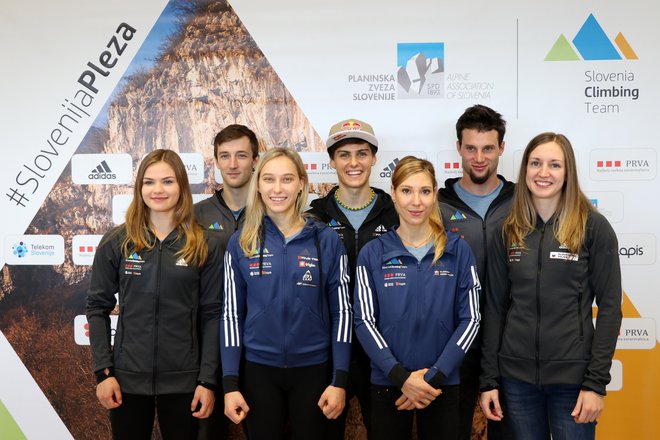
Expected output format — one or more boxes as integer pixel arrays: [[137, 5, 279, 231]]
[[391, 172, 437, 226]]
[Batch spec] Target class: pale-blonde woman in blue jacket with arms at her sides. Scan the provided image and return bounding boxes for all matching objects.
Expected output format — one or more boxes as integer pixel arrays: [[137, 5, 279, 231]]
[[220, 148, 353, 440]]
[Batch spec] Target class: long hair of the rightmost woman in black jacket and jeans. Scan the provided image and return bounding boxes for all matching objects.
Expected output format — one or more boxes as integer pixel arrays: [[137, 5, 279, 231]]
[[502, 132, 594, 253]]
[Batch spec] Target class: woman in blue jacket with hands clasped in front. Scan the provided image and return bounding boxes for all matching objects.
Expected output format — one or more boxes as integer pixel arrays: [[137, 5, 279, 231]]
[[354, 156, 481, 440]]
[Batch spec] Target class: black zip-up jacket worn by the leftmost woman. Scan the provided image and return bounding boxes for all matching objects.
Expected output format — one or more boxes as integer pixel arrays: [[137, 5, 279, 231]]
[[87, 225, 225, 395]]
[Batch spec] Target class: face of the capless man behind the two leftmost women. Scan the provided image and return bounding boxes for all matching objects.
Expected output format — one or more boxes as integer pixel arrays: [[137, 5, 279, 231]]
[[215, 136, 259, 188]]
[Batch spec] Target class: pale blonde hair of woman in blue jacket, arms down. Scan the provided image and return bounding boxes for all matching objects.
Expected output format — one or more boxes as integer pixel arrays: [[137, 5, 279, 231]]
[[238, 147, 309, 256]]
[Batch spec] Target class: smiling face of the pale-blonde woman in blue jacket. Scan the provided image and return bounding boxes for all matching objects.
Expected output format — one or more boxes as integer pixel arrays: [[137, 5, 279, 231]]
[[257, 156, 304, 216]]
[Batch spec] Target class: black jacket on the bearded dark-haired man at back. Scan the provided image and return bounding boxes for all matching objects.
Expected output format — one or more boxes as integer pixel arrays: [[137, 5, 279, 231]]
[[438, 175, 515, 351]]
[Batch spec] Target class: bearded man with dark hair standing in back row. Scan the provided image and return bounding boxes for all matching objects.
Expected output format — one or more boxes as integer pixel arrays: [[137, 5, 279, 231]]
[[438, 105, 514, 440]]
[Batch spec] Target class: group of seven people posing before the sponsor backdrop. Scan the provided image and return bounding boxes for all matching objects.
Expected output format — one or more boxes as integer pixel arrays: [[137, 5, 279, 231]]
[[87, 105, 622, 440]]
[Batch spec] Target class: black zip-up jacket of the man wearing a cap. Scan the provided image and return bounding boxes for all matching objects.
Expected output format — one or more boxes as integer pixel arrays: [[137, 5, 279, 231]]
[[307, 186, 399, 292]]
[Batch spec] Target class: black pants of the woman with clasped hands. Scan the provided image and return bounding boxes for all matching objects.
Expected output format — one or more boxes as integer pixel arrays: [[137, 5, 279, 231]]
[[370, 385, 459, 440]]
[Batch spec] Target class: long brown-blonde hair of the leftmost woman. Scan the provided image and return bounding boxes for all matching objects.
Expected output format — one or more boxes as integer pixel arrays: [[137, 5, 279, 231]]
[[122, 149, 208, 265]]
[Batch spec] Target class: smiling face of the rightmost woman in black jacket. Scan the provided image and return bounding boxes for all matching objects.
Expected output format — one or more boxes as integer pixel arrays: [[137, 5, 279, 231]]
[[525, 142, 566, 208]]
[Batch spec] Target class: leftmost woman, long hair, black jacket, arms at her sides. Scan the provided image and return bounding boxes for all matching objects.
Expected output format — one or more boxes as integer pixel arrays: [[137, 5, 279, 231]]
[[87, 150, 224, 440]]
